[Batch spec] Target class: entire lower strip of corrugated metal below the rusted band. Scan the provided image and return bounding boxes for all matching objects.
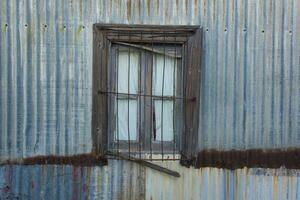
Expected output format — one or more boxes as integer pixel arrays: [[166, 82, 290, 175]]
[[0, 161, 300, 200]]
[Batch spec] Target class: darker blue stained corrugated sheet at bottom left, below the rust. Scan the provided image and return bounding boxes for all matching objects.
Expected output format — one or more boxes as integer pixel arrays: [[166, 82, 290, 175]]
[[0, 161, 145, 200]]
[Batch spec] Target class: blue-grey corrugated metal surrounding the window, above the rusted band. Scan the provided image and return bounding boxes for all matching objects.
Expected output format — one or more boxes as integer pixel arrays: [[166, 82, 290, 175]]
[[0, 0, 300, 158]]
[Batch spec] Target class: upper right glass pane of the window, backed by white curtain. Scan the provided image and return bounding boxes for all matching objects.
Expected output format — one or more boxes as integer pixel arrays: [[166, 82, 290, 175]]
[[152, 55, 177, 96]]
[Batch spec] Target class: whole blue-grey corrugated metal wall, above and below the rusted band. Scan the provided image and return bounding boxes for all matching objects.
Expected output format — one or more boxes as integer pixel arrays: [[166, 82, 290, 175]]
[[0, 0, 300, 199]]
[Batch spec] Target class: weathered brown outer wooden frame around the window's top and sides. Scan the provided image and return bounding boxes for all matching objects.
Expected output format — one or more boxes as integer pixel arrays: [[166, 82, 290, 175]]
[[92, 24, 202, 158]]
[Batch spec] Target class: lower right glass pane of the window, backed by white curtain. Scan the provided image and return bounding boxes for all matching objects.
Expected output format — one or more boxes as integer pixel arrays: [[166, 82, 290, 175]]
[[153, 100, 174, 141]]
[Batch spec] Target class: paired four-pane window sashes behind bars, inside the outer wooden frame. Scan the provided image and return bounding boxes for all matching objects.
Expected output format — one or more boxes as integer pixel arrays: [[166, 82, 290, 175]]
[[108, 43, 183, 154]]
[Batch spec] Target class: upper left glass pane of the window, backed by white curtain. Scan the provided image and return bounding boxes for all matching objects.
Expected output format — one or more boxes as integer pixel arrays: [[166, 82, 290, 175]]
[[118, 50, 140, 94]]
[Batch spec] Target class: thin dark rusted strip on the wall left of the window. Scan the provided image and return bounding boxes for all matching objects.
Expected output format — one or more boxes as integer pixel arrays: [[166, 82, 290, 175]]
[[0, 154, 107, 166]]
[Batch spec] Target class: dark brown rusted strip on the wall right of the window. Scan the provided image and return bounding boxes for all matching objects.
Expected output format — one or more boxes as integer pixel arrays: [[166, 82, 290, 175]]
[[180, 148, 300, 169]]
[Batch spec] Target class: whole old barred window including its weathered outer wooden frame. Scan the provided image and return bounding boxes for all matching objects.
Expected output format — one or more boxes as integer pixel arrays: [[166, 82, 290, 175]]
[[92, 24, 201, 159]]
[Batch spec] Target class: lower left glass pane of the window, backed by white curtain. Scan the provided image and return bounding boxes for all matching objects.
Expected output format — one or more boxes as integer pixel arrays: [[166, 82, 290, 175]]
[[115, 99, 138, 140]]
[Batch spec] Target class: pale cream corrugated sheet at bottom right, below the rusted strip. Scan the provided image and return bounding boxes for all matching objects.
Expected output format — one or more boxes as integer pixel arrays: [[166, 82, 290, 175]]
[[146, 162, 300, 200]]
